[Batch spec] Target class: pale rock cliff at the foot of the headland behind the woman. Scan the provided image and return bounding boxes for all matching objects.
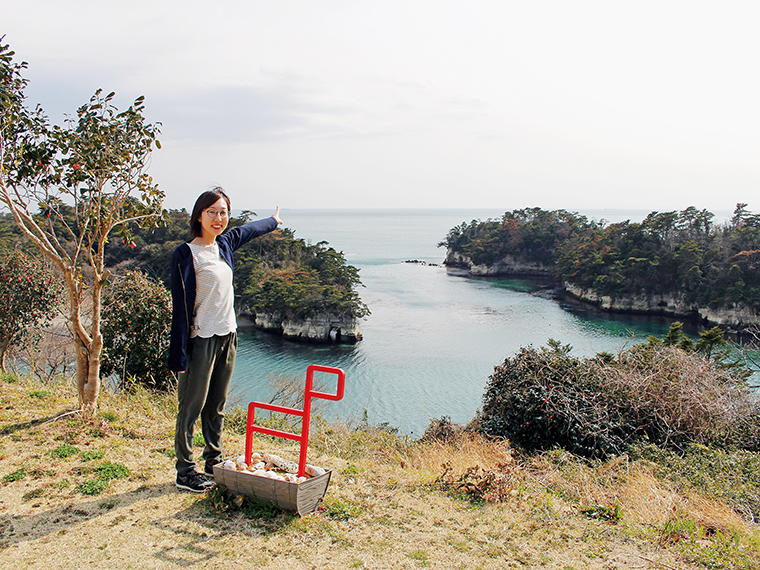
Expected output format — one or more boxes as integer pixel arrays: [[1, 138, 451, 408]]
[[245, 313, 362, 343]]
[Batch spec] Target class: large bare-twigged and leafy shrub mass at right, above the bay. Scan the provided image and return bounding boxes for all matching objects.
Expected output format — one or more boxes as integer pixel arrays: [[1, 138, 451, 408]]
[[479, 340, 760, 458]]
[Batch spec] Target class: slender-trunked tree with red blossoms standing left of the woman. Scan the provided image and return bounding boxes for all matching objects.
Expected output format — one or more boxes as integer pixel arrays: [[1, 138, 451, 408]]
[[0, 38, 164, 417]]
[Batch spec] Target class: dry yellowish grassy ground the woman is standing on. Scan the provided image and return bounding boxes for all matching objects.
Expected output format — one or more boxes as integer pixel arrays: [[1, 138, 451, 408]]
[[0, 372, 760, 569]]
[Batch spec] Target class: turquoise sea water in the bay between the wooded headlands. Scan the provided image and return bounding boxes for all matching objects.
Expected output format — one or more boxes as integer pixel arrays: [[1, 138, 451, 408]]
[[230, 210, 724, 436]]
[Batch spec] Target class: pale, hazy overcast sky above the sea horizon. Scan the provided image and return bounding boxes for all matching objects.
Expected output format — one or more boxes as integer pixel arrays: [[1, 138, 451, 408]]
[[0, 0, 760, 214]]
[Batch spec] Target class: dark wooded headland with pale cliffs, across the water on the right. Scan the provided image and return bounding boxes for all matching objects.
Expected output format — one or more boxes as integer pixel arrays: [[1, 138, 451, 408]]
[[439, 204, 760, 331]]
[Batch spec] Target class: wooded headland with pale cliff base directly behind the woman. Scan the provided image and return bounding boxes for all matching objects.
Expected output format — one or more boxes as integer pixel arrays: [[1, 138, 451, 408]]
[[0, 206, 369, 343]]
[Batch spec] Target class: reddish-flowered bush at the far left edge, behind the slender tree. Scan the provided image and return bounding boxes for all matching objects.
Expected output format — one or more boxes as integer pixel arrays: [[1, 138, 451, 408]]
[[0, 251, 62, 372]]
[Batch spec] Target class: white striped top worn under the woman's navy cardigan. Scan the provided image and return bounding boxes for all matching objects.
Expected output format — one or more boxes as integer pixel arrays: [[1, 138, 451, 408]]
[[187, 243, 237, 338]]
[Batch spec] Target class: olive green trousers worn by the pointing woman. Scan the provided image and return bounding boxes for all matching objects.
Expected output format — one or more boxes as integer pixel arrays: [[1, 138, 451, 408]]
[[174, 332, 237, 475]]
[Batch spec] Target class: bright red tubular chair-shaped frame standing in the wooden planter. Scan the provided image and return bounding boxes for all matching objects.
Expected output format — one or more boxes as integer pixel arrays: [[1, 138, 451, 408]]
[[245, 364, 346, 477]]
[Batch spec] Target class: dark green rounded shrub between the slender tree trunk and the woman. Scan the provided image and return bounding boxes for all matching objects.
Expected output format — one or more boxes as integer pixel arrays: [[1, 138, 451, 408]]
[[101, 271, 173, 390]]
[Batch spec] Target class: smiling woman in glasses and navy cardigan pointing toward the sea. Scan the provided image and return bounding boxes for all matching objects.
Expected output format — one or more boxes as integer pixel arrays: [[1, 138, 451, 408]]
[[169, 187, 282, 493]]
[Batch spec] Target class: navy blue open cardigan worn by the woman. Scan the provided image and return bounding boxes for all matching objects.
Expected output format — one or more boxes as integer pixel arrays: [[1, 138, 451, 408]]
[[169, 216, 277, 372]]
